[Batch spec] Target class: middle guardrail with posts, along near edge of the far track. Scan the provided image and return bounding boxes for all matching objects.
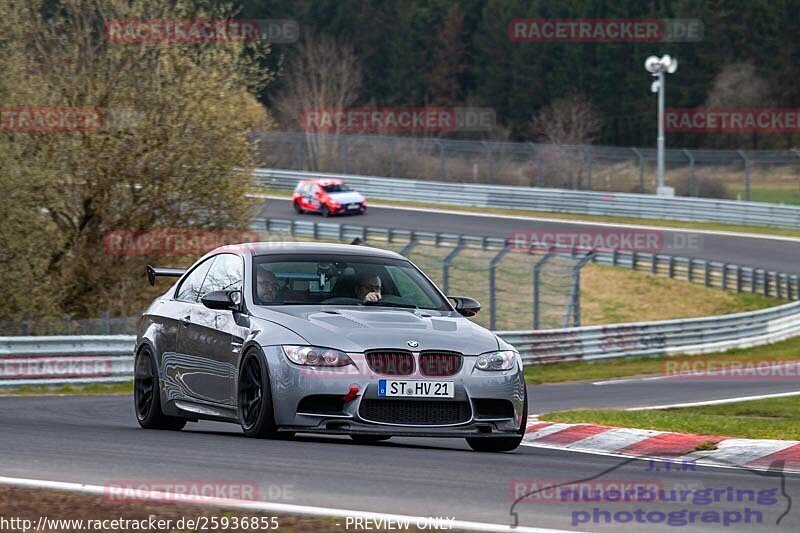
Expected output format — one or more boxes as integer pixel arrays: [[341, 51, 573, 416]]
[[260, 218, 800, 300]]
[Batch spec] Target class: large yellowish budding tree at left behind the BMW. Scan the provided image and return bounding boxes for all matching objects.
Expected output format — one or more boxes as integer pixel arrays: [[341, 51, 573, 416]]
[[0, 0, 270, 318]]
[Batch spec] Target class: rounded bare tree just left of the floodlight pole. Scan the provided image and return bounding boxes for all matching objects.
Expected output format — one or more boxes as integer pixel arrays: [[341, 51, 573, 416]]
[[530, 94, 603, 189]]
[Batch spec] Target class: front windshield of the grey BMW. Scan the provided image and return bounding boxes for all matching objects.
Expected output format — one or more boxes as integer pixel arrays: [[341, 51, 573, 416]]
[[253, 255, 451, 311]]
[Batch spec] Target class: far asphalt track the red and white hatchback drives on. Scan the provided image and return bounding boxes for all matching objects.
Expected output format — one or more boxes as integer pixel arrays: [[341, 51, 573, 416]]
[[261, 198, 800, 274]]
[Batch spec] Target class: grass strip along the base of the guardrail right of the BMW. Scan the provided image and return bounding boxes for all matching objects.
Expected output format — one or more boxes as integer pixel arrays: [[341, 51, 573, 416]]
[[525, 337, 800, 385]]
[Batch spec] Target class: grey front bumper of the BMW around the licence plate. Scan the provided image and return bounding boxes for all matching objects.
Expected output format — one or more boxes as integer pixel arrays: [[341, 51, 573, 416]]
[[265, 348, 526, 437]]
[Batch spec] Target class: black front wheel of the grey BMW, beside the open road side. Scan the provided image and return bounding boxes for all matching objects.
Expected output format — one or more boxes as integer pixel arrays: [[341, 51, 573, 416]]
[[237, 350, 278, 438]]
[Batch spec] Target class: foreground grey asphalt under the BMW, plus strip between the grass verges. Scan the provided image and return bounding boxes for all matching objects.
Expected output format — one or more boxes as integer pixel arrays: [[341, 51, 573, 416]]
[[0, 381, 800, 531]]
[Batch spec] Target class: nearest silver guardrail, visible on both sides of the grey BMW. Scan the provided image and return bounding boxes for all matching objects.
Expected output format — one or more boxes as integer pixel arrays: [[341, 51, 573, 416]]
[[6, 302, 800, 387]]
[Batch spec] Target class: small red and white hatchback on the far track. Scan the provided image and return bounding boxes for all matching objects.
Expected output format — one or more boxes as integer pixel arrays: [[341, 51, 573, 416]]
[[292, 179, 367, 217]]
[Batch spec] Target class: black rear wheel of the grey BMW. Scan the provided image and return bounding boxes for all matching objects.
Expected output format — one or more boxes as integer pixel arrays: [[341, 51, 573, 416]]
[[138, 348, 186, 431]]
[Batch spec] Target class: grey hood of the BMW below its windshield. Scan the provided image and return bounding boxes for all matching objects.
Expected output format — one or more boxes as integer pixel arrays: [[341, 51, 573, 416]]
[[254, 305, 499, 355]]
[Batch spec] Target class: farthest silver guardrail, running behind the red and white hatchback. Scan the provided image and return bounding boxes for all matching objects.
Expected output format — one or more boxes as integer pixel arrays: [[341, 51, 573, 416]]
[[253, 168, 800, 229]]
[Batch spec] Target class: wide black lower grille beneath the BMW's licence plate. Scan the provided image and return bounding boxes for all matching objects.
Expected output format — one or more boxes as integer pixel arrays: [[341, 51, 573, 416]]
[[358, 398, 470, 426]]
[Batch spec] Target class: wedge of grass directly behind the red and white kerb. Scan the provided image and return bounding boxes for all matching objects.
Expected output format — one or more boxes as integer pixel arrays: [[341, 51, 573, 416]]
[[539, 396, 800, 440]]
